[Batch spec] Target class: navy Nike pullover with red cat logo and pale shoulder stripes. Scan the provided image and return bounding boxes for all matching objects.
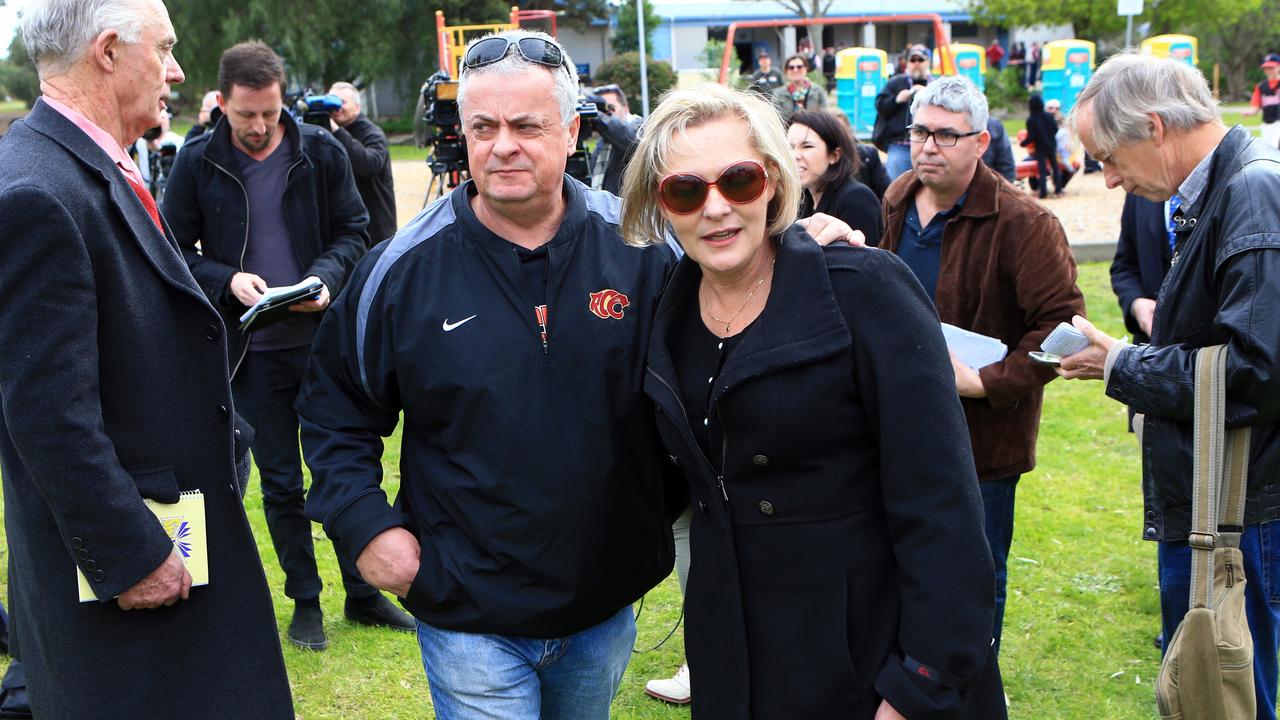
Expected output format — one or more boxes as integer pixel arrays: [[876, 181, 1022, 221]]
[[297, 177, 682, 638]]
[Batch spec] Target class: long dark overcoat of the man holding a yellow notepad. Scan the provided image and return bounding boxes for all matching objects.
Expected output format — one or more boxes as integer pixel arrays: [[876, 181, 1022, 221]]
[[0, 102, 293, 720]]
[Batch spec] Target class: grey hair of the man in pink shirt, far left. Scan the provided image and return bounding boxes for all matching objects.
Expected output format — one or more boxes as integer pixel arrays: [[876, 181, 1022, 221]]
[[19, 0, 147, 78]]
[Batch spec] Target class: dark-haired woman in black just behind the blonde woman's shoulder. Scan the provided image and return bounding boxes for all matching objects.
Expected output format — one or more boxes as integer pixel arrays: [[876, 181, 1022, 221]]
[[787, 110, 884, 246]]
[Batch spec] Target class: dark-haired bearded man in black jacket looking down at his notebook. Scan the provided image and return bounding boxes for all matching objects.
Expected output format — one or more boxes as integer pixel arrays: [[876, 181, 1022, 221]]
[[164, 42, 412, 650]]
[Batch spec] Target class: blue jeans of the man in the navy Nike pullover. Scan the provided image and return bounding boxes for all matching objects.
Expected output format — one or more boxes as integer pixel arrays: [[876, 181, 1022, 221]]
[[417, 606, 636, 720]]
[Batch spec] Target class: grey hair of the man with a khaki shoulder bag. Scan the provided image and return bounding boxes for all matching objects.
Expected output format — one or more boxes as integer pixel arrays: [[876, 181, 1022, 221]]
[[1071, 51, 1217, 158]]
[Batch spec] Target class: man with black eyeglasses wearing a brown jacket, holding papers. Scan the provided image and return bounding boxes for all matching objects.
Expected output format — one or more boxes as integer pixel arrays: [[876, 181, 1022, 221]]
[[881, 76, 1084, 652]]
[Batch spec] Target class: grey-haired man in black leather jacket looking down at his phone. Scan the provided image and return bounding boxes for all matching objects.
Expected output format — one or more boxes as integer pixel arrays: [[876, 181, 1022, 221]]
[[1060, 53, 1280, 720]]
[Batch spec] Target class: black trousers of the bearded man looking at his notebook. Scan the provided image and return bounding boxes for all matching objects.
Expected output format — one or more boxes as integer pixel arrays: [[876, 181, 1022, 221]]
[[232, 346, 378, 600]]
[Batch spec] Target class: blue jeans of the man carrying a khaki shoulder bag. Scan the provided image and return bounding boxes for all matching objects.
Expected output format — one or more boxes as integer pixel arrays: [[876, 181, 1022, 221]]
[[1157, 520, 1280, 720]]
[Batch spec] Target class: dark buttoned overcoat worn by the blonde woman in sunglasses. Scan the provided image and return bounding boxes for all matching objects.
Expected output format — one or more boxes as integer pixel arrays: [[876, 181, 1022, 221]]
[[645, 229, 1005, 720]]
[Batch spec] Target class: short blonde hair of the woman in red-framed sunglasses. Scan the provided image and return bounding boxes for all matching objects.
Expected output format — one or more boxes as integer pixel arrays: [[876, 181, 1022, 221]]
[[622, 83, 801, 246]]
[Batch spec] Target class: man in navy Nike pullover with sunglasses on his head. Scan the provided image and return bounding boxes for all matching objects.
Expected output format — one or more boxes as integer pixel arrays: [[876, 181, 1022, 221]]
[[298, 31, 682, 720]]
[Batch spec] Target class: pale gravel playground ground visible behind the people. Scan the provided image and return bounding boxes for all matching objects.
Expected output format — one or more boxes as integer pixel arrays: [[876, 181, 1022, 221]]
[[392, 155, 1124, 251]]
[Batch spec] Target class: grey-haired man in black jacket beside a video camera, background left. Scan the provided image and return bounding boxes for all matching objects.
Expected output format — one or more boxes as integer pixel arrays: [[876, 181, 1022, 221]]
[[329, 82, 397, 247]]
